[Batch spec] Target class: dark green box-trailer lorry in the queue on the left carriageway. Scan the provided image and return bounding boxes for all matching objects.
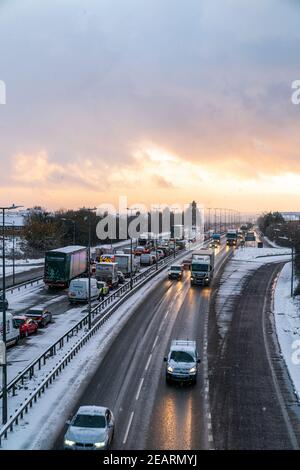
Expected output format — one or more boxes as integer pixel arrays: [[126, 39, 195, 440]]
[[44, 246, 88, 287]]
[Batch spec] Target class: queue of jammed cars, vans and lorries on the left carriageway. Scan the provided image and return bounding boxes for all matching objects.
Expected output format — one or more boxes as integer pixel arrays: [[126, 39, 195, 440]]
[[0, 234, 191, 347]]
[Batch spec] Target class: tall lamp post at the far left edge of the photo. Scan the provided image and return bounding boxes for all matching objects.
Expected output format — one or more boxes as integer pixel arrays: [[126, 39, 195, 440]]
[[0, 204, 23, 424]]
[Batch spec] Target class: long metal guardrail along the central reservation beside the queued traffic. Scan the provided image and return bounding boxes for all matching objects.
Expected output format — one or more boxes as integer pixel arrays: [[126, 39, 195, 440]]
[[0, 246, 192, 447]]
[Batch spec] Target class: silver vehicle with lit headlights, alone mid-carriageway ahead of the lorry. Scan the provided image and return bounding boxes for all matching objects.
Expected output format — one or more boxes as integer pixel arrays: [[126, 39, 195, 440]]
[[164, 339, 200, 384]]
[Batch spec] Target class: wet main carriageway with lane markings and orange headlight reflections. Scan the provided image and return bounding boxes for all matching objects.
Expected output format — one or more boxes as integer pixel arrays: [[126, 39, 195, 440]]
[[54, 241, 230, 450]]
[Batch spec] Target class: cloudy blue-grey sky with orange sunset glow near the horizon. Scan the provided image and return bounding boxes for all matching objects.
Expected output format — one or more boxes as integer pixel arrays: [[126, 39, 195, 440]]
[[0, 0, 300, 212]]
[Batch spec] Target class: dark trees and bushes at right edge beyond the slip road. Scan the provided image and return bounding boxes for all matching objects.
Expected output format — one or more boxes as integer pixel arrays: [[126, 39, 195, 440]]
[[258, 212, 300, 295]]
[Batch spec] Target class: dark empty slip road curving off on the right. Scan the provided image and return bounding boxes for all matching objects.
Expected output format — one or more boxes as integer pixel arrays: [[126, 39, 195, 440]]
[[208, 263, 300, 450]]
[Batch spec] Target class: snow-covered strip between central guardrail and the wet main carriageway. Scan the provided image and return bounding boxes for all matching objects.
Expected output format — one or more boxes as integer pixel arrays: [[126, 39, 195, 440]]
[[2, 262, 172, 449]]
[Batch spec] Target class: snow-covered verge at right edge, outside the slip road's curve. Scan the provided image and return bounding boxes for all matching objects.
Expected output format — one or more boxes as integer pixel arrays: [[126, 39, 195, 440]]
[[273, 263, 300, 400]]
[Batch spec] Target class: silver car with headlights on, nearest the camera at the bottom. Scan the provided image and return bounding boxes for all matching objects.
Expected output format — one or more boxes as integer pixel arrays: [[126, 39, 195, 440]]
[[64, 406, 115, 450]]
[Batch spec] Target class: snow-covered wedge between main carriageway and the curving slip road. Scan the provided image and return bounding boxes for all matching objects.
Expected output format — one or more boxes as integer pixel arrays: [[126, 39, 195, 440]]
[[216, 247, 291, 338]]
